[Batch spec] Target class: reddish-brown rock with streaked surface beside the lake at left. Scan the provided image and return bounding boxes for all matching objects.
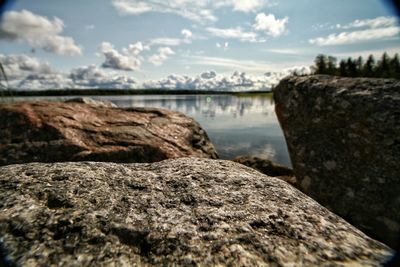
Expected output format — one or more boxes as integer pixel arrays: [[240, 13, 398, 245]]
[[0, 99, 218, 165]]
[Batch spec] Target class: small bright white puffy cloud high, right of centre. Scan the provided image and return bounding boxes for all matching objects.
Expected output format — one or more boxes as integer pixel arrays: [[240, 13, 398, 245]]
[[253, 13, 289, 37]]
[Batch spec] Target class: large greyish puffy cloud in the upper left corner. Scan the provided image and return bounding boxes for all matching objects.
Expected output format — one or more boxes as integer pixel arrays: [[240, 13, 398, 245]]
[[0, 10, 82, 55]]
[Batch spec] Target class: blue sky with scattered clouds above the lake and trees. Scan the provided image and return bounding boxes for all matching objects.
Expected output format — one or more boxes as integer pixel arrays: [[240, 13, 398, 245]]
[[0, 0, 400, 90]]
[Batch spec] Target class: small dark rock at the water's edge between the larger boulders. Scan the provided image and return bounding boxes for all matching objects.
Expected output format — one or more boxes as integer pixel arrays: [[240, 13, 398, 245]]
[[233, 156, 297, 187]]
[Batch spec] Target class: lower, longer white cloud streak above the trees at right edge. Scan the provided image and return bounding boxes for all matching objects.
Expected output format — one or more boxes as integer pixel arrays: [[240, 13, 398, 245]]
[[309, 27, 400, 46]]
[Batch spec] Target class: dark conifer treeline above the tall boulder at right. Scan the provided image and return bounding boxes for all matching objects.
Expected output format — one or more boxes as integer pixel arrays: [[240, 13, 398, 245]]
[[312, 52, 400, 79]]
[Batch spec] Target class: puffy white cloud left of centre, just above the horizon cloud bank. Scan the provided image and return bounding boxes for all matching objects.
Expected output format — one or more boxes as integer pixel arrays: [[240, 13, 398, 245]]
[[101, 42, 145, 71]]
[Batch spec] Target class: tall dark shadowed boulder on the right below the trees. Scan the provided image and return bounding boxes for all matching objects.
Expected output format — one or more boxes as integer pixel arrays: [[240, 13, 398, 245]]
[[274, 76, 400, 249]]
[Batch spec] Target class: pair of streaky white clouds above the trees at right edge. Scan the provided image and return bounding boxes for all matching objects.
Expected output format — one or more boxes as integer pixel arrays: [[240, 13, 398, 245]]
[[309, 17, 400, 46]]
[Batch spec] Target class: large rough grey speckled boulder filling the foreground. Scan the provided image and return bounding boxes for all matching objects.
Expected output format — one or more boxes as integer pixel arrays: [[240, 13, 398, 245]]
[[0, 158, 392, 266]]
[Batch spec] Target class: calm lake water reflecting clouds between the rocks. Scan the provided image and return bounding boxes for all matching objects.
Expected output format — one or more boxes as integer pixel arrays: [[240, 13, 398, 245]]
[[4, 95, 291, 166]]
